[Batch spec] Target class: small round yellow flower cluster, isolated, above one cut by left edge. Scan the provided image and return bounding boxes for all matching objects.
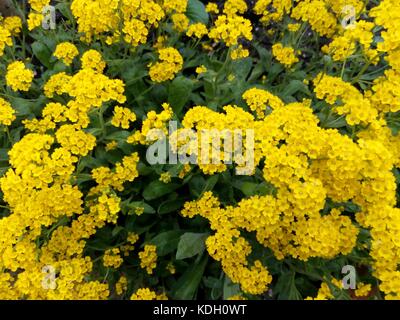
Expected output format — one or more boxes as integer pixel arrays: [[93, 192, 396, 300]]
[[6, 61, 34, 91]]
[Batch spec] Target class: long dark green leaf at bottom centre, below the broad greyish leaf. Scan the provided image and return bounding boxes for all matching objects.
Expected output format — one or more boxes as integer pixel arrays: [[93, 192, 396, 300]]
[[170, 256, 208, 300]]
